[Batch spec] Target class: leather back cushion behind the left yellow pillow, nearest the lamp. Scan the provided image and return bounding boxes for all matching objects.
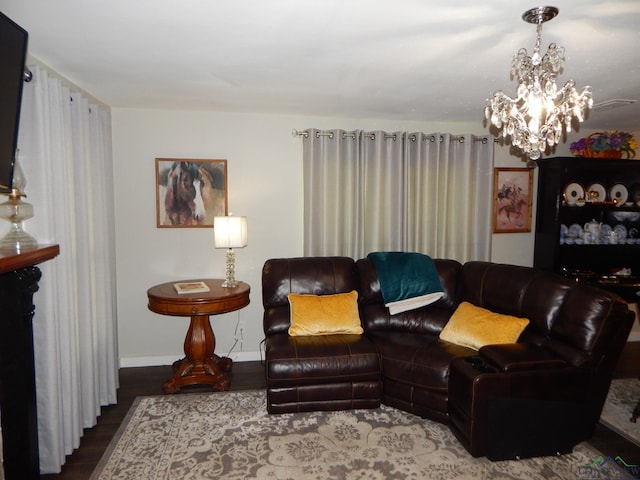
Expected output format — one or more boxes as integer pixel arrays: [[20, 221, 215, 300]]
[[262, 257, 358, 337]]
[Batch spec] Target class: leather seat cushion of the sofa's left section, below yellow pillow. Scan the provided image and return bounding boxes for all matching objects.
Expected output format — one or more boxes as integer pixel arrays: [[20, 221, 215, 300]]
[[266, 334, 380, 387]]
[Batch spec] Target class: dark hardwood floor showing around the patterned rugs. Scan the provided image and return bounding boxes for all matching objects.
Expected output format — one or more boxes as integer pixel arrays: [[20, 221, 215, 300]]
[[40, 342, 640, 480]]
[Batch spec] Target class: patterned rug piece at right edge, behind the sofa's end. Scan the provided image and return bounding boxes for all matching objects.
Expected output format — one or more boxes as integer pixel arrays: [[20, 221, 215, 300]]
[[600, 378, 640, 446]]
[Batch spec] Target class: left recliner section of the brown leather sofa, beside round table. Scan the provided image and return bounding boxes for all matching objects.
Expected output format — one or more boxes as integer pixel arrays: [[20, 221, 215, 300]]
[[262, 257, 382, 413]]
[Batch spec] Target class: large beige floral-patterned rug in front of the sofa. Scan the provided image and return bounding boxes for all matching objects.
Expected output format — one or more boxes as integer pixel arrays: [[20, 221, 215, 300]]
[[91, 390, 617, 480]]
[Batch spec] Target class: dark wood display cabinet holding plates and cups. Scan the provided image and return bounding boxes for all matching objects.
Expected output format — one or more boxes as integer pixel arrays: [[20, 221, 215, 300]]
[[533, 157, 640, 303]]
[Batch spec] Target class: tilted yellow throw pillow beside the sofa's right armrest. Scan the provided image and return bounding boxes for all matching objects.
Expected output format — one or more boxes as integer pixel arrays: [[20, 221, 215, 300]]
[[440, 302, 529, 350]]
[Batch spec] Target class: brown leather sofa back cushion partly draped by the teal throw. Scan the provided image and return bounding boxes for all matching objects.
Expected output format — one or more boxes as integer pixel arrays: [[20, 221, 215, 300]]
[[356, 258, 462, 335]]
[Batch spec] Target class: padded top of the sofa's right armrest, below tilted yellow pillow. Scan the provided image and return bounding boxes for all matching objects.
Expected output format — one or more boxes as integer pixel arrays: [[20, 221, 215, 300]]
[[478, 343, 567, 372]]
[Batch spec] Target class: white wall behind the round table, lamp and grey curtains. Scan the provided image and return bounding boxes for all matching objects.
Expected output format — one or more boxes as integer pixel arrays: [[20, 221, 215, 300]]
[[112, 108, 560, 366]]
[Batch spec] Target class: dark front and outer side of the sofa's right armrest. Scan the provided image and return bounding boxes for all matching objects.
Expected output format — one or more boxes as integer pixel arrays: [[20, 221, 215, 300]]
[[448, 356, 600, 460]]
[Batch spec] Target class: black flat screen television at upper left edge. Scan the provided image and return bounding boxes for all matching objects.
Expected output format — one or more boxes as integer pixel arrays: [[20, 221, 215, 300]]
[[0, 12, 29, 193]]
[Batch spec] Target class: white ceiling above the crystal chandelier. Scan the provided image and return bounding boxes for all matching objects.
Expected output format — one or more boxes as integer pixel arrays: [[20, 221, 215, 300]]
[[0, 0, 640, 131]]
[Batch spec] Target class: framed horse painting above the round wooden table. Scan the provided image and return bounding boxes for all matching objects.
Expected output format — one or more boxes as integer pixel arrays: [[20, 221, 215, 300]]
[[156, 158, 227, 228]]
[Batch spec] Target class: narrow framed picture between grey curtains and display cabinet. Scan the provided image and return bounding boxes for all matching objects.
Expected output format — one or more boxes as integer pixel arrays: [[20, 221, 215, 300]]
[[493, 168, 533, 233]]
